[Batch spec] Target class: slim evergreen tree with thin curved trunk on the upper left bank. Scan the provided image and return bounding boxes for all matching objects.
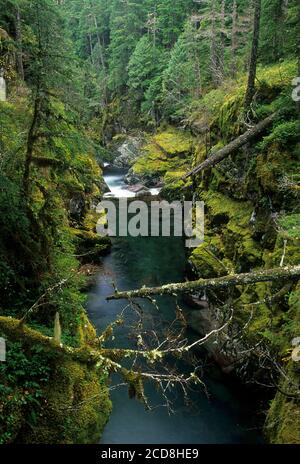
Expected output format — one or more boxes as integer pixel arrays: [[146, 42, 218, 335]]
[[23, 0, 71, 196]]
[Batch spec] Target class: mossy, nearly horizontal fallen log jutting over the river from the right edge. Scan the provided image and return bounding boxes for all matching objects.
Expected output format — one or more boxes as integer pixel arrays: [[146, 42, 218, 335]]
[[107, 265, 300, 300]]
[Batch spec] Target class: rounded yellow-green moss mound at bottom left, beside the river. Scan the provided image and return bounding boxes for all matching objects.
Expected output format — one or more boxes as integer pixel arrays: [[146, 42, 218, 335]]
[[21, 361, 111, 444]]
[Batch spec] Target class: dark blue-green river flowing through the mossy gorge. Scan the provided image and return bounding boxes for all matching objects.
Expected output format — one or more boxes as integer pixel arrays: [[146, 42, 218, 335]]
[[88, 168, 262, 444]]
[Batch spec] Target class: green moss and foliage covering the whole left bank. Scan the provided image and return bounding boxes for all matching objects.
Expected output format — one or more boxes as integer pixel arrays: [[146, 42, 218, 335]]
[[0, 70, 111, 444]]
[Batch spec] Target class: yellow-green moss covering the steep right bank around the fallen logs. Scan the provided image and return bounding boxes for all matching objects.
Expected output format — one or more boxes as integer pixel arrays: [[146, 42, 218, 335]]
[[182, 60, 300, 443]]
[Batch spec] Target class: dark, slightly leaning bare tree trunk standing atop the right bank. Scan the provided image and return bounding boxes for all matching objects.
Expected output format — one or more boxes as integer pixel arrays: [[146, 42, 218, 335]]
[[245, 0, 261, 109]]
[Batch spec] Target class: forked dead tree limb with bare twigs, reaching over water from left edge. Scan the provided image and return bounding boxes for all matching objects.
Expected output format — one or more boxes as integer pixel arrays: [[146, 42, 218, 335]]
[[0, 316, 227, 408]]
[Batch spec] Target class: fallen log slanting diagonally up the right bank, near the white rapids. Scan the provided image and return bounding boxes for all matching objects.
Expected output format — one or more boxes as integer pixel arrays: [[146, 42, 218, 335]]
[[182, 113, 278, 180]]
